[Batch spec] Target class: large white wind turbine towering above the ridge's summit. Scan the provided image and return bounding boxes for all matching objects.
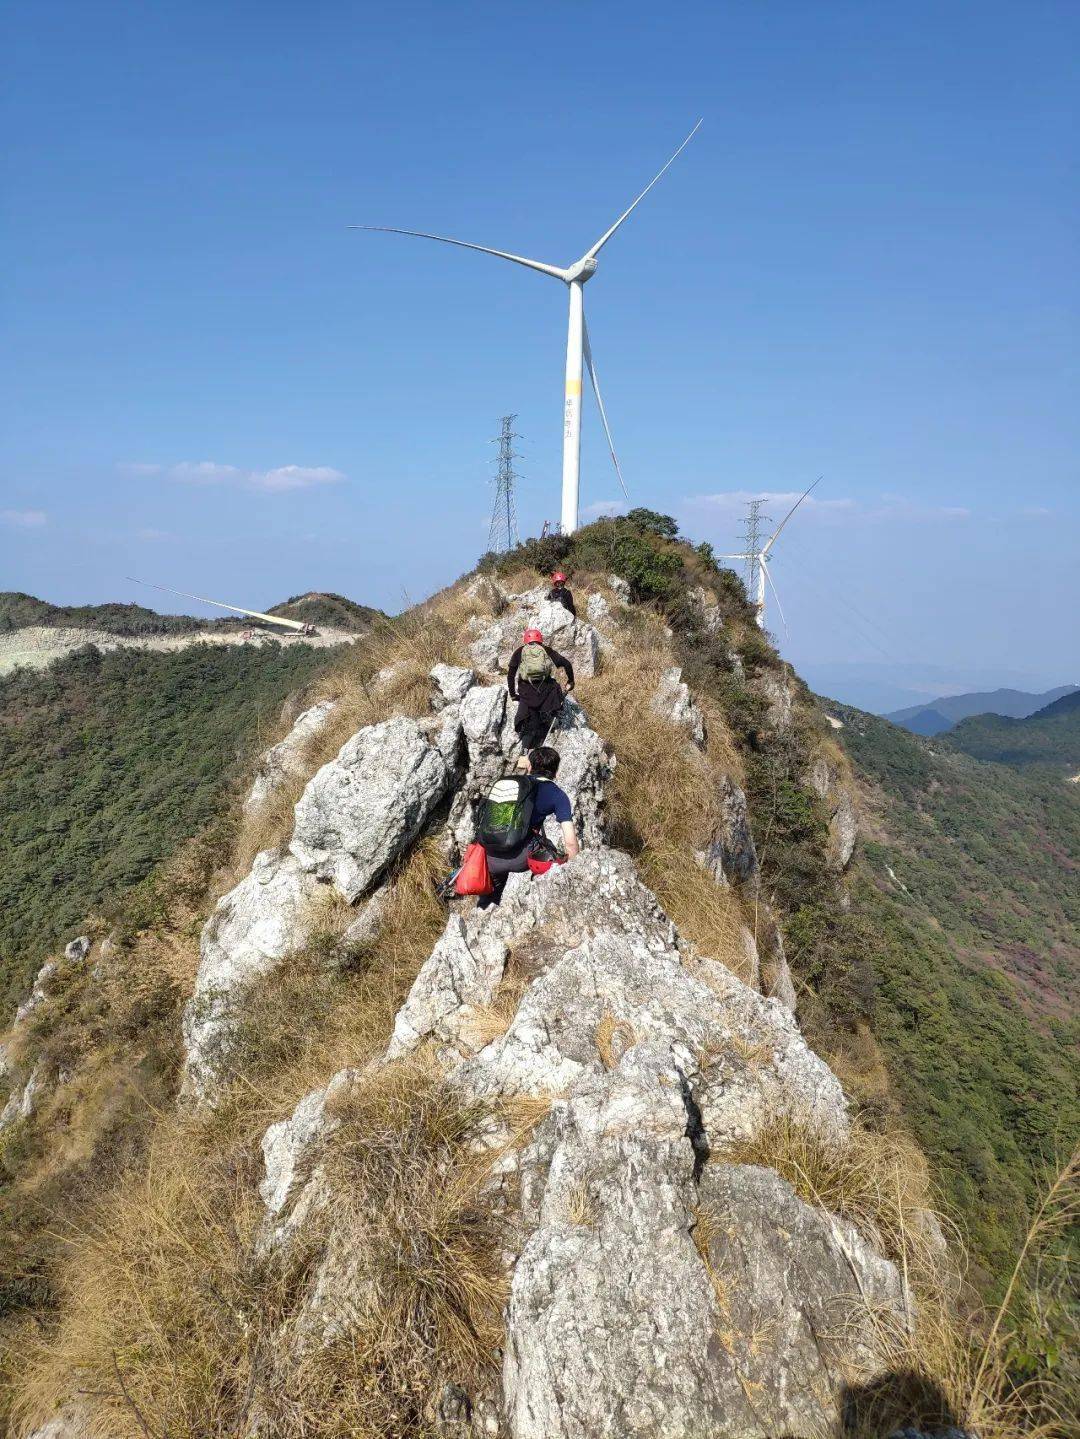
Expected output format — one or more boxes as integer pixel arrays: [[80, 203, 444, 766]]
[[348, 119, 702, 534]]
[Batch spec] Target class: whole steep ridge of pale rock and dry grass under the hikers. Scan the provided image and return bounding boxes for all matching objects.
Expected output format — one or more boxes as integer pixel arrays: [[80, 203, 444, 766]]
[[4, 558, 977, 1439]]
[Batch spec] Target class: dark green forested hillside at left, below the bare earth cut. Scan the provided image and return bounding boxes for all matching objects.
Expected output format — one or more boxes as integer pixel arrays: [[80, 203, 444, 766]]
[[0, 641, 337, 1012]]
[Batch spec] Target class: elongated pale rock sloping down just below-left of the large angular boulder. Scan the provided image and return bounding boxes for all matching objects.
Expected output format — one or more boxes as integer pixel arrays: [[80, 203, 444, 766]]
[[181, 849, 316, 1099]]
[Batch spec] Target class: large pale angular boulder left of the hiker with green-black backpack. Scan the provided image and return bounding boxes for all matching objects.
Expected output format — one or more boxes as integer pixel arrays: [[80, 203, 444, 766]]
[[289, 718, 450, 904]]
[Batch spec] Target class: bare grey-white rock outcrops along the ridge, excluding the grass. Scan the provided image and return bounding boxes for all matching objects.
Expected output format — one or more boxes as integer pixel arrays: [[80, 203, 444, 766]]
[[8, 580, 907, 1439]]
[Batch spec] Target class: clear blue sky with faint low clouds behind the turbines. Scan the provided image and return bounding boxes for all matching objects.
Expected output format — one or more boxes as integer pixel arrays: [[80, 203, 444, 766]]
[[0, 0, 1080, 699]]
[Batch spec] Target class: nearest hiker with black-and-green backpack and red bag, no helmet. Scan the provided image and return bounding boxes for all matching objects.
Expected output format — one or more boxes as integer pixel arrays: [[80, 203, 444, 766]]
[[476, 745, 580, 909]]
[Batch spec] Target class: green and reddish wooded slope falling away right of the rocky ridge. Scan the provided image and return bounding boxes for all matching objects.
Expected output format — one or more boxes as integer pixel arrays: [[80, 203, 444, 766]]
[[830, 705, 1080, 1272]]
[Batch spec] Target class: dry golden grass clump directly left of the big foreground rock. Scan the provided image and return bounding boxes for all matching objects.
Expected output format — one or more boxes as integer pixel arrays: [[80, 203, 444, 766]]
[[266, 1055, 508, 1439]]
